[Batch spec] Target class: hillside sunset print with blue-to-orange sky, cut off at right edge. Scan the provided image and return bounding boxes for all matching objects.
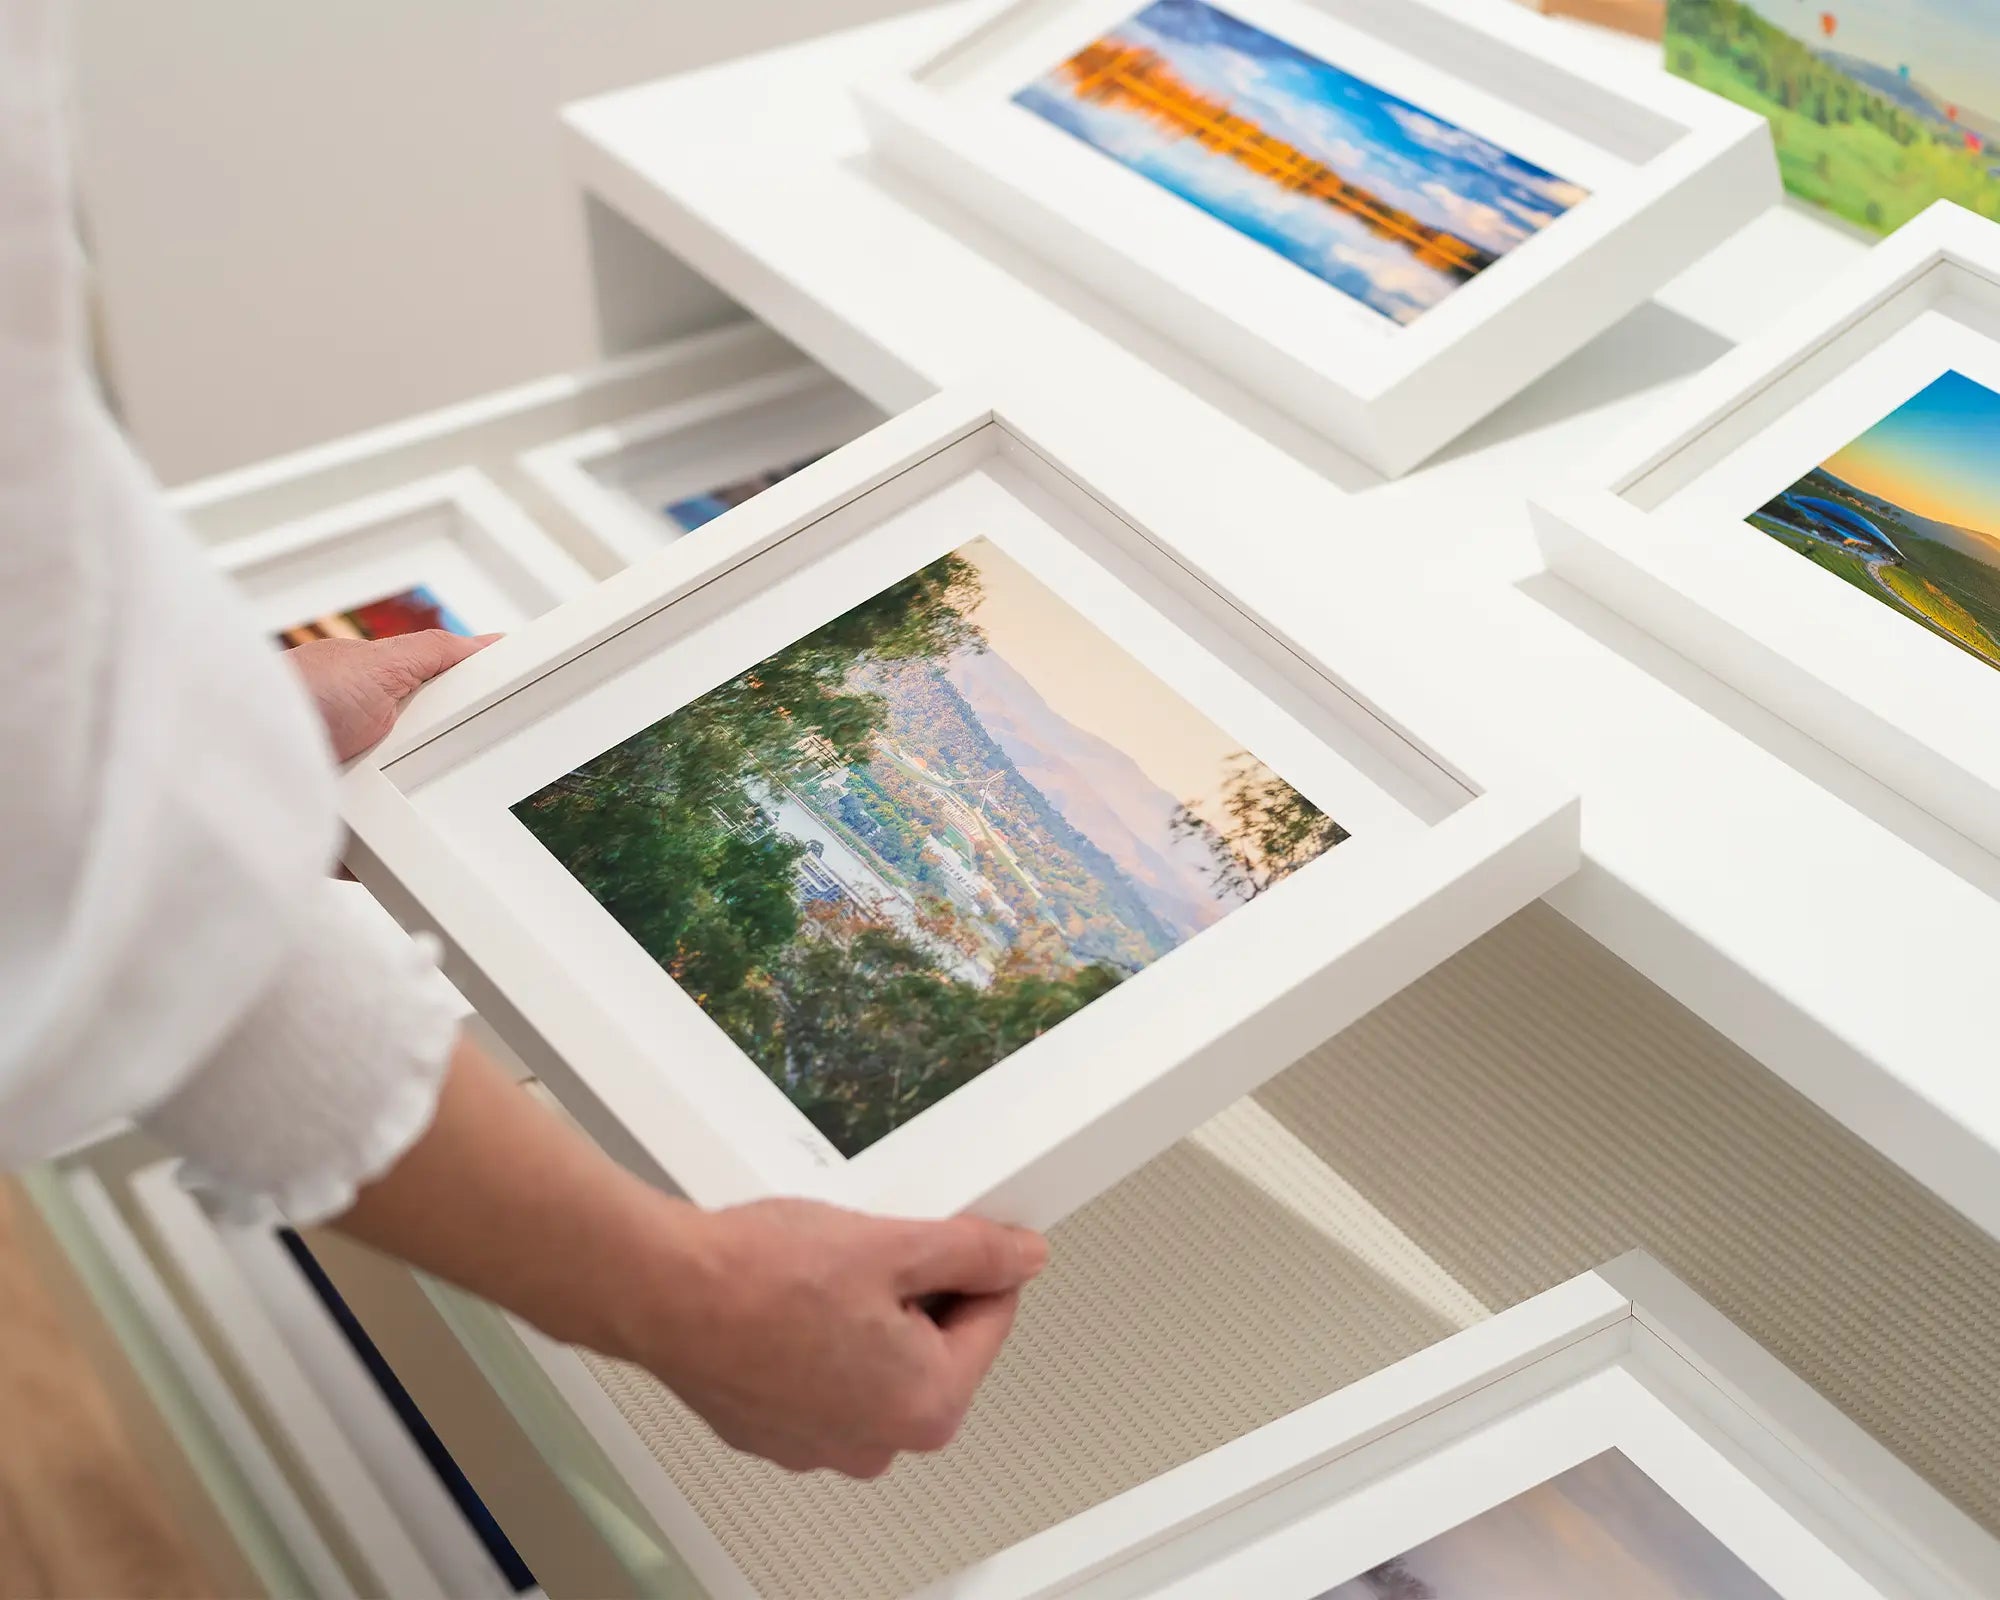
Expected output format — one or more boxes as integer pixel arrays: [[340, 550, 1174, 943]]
[[1750, 372, 2000, 666]]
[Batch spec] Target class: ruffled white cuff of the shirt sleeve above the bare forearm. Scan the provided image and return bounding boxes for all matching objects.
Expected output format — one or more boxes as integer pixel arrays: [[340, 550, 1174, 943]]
[[142, 882, 466, 1226]]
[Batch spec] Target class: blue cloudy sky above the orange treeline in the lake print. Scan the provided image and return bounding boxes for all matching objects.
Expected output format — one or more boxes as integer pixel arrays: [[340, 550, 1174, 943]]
[[1088, 0, 1584, 254]]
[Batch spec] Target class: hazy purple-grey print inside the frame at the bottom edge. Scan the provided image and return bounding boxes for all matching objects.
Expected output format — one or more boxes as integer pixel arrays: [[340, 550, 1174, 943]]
[[1320, 1450, 1780, 1600]]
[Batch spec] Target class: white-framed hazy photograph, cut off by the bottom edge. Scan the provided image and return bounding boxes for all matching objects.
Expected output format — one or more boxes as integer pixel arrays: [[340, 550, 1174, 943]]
[[920, 1254, 2000, 1600]]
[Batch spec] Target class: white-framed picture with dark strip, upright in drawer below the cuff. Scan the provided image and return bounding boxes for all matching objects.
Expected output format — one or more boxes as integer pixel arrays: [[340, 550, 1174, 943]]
[[128, 1162, 542, 1600]]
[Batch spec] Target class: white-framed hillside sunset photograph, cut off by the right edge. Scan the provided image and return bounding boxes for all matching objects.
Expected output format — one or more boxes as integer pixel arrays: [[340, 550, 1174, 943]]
[[1536, 204, 2000, 868]]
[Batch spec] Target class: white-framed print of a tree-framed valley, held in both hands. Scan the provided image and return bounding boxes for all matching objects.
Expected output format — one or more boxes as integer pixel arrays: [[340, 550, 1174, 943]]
[[346, 390, 1576, 1224]]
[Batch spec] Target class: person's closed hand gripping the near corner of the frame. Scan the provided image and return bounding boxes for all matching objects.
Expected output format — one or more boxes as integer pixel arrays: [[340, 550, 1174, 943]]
[[626, 1200, 1048, 1478]]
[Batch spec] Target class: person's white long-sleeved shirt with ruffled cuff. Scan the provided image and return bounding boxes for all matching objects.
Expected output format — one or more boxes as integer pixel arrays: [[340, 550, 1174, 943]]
[[0, 0, 456, 1222]]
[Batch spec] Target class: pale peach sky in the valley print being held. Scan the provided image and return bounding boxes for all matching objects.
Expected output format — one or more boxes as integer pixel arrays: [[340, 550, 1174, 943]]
[[958, 538, 1242, 810]]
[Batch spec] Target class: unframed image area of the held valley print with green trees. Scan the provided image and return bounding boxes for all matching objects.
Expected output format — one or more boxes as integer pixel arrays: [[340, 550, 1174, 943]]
[[512, 538, 1346, 1156]]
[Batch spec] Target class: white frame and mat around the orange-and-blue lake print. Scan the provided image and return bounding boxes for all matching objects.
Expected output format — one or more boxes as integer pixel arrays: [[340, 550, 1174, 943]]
[[856, 0, 1780, 476]]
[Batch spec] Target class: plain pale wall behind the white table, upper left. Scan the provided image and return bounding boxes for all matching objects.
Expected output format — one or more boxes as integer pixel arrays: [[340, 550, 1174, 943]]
[[72, 0, 928, 482]]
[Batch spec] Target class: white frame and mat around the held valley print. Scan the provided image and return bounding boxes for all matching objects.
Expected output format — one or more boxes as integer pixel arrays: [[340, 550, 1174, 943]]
[[344, 386, 1578, 1226]]
